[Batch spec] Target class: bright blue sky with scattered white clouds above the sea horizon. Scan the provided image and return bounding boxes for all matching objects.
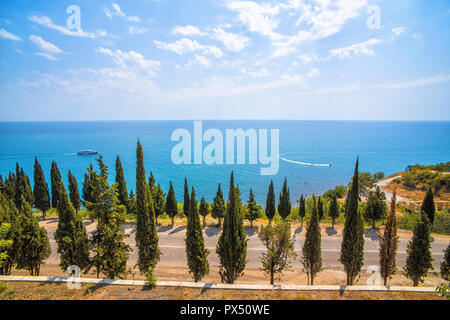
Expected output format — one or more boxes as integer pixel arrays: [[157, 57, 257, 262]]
[[0, 0, 450, 121]]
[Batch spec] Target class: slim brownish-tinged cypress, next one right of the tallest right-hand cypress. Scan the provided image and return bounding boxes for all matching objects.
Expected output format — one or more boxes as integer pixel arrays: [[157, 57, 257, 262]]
[[380, 190, 398, 286]]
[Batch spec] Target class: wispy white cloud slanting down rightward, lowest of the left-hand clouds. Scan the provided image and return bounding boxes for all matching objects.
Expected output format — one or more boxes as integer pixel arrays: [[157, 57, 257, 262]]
[[96, 47, 161, 76]]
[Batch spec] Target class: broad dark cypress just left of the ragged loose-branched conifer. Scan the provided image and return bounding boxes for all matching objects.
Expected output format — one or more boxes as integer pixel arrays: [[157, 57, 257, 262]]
[[54, 185, 89, 272]]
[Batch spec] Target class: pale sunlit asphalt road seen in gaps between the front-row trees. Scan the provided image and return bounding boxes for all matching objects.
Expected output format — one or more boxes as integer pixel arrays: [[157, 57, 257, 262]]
[[41, 219, 450, 271]]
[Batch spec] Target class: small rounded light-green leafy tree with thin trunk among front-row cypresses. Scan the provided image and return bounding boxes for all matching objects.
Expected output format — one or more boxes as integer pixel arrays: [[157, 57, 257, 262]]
[[258, 222, 297, 285]]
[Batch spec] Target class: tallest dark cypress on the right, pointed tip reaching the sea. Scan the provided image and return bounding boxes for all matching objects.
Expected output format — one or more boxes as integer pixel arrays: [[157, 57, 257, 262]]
[[339, 159, 364, 286]]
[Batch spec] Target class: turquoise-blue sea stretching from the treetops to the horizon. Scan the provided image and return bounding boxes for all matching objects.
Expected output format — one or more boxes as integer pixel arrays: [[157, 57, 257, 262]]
[[0, 121, 450, 204]]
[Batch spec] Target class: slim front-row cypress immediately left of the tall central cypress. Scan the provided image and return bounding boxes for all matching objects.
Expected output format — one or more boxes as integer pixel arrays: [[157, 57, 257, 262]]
[[185, 187, 209, 282]]
